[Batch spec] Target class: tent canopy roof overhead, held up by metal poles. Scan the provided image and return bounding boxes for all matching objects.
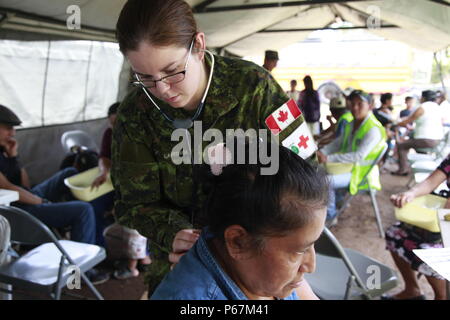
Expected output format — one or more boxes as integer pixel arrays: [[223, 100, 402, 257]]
[[0, 0, 450, 56]]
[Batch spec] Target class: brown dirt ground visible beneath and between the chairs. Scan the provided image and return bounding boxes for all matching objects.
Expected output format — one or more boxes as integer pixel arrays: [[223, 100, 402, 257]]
[[16, 163, 433, 300]]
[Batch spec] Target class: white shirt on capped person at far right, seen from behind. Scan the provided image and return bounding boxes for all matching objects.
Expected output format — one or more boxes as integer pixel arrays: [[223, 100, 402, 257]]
[[414, 101, 444, 140]]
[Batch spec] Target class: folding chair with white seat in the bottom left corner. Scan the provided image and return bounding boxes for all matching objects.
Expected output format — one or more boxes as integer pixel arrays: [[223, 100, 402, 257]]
[[0, 206, 106, 300]]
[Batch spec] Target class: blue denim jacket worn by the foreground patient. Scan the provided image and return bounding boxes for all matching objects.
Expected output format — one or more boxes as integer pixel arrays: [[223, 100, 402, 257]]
[[150, 228, 297, 300]]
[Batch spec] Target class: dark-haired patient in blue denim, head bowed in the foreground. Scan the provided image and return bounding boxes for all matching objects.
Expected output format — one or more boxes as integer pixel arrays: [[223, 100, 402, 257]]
[[151, 141, 328, 300]]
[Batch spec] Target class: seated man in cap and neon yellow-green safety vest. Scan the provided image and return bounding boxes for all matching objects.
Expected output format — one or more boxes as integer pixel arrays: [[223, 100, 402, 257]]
[[317, 90, 386, 226]]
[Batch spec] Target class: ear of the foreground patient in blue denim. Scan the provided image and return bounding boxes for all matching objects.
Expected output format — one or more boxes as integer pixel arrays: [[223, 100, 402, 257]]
[[223, 224, 251, 260]]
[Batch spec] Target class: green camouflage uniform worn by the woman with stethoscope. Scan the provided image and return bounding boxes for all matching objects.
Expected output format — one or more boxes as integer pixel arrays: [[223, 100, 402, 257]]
[[111, 56, 304, 294]]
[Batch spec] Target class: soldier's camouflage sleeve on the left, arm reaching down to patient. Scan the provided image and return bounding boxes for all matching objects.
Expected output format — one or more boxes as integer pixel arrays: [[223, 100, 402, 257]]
[[111, 101, 191, 253]]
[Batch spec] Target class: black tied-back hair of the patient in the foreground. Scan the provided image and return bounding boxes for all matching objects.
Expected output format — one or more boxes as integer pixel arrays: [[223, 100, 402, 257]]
[[204, 139, 329, 249]]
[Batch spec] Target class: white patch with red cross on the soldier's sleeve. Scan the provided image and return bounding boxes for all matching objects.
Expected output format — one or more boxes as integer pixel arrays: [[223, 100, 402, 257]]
[[281, 122, 317, 159]]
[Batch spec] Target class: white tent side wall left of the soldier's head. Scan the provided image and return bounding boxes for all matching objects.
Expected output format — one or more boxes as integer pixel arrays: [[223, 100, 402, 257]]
[[0, 40, 123, 127]]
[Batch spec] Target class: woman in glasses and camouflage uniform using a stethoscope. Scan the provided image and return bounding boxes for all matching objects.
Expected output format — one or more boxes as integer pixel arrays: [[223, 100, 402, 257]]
[[111, 0, 312, 294]]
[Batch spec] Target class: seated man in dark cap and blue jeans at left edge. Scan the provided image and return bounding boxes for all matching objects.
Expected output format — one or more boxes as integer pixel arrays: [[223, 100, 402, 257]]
[[0, 105, 109, 284]]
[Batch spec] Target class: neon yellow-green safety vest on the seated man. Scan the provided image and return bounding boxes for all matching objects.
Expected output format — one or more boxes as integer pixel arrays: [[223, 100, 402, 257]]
[[340, 113, 386, 195]]
